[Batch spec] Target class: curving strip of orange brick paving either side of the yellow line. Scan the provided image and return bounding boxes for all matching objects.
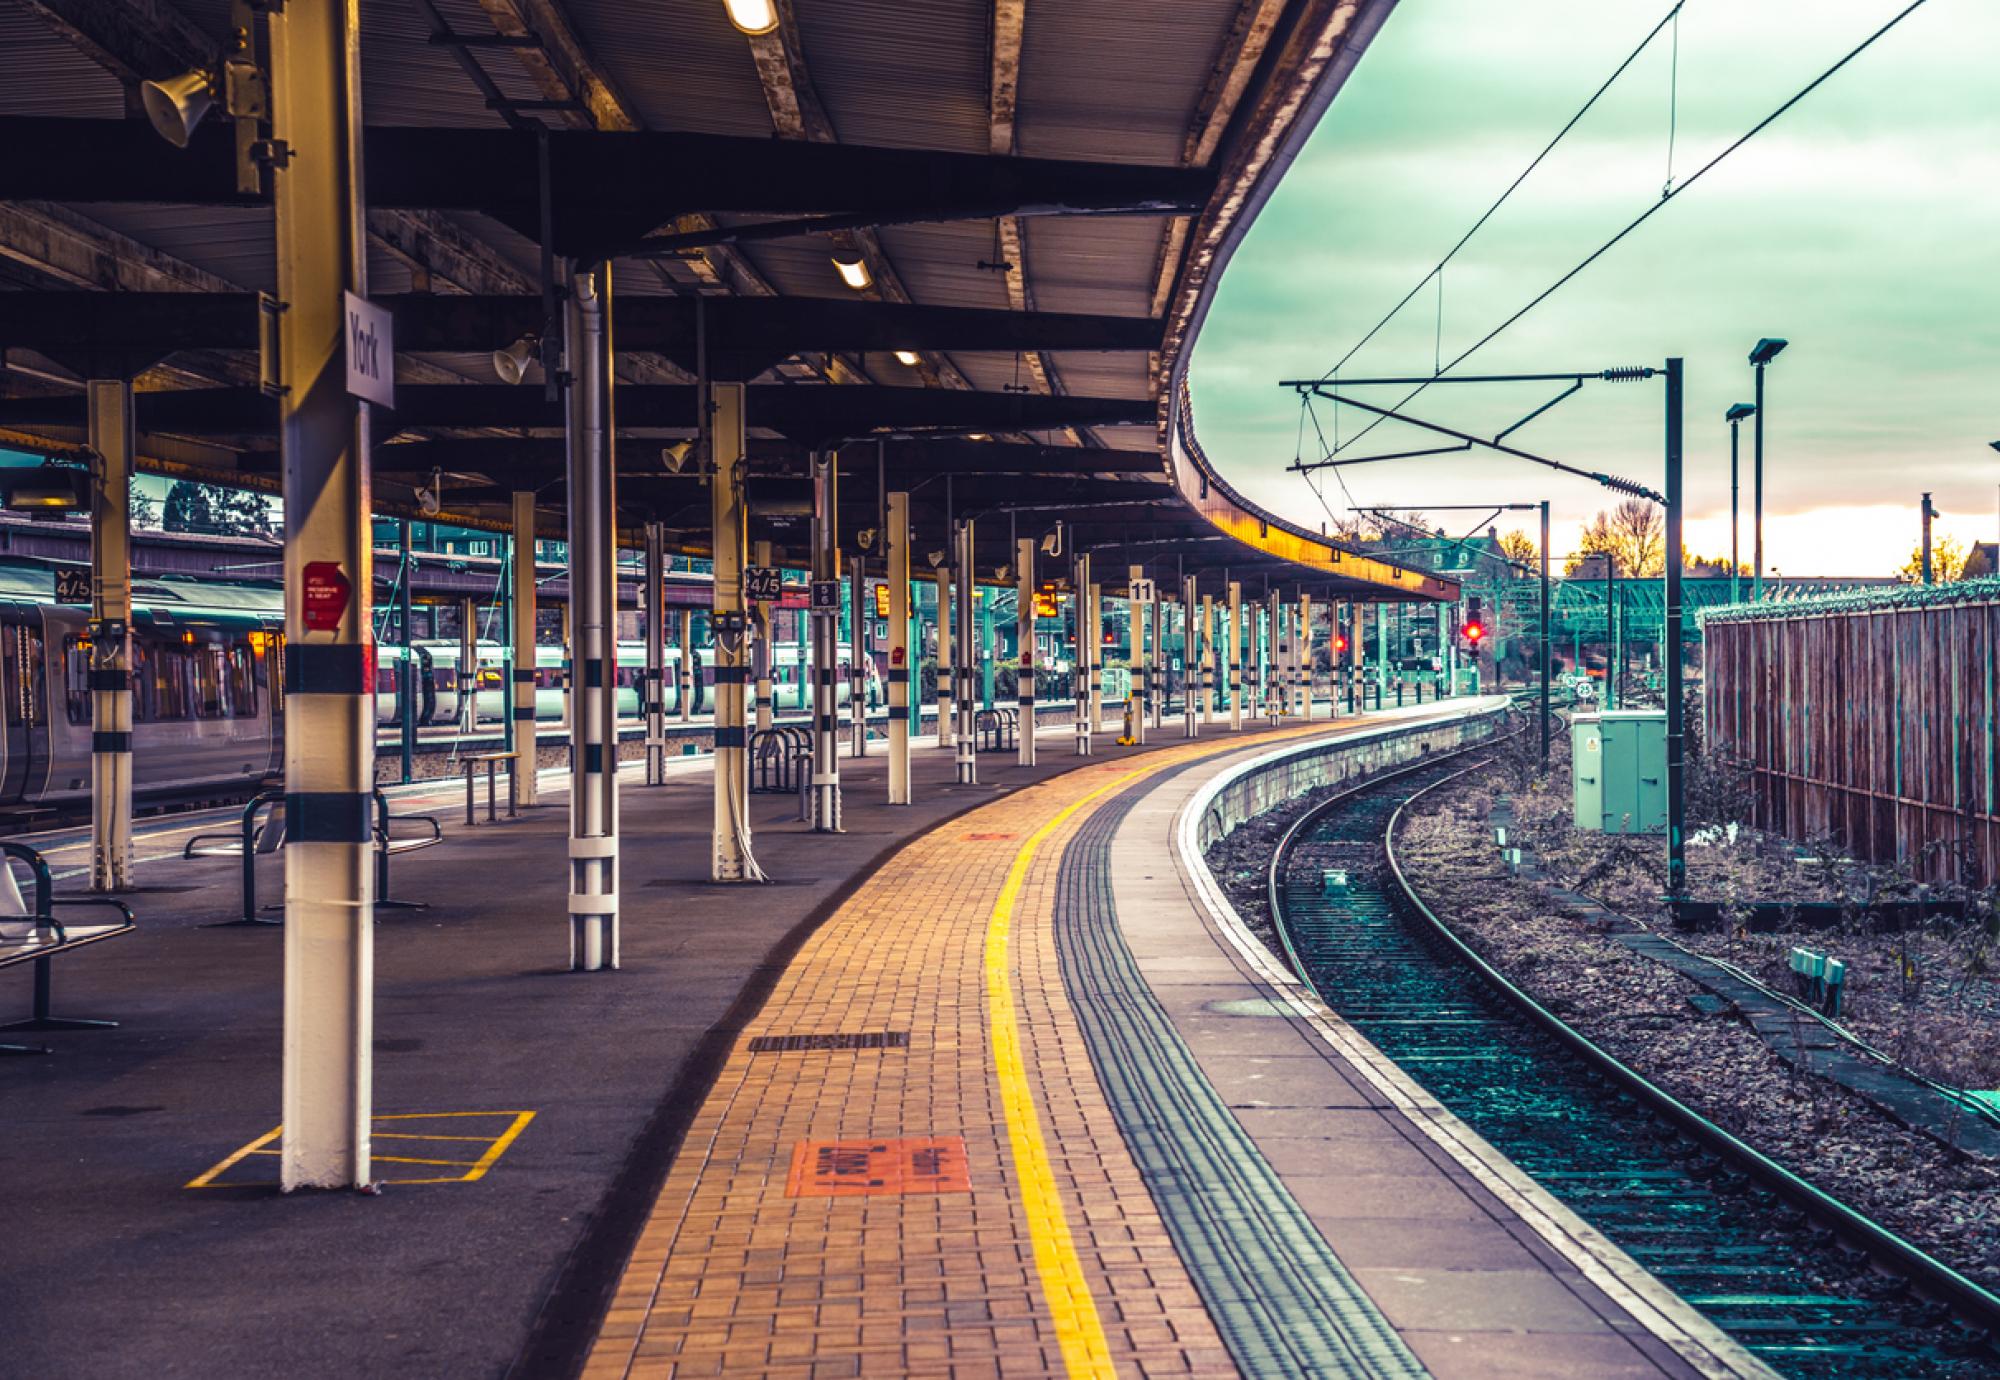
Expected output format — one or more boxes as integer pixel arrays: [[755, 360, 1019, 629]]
[[584, 722, 1360, 1380]]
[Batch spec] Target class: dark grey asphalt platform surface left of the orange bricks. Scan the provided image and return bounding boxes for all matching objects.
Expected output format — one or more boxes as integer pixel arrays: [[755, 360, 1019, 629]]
[[0, 728, 1288, 1380]]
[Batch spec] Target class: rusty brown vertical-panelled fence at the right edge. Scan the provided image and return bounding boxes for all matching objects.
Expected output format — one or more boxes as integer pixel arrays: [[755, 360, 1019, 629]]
[[1704, 580, 2000, 886]]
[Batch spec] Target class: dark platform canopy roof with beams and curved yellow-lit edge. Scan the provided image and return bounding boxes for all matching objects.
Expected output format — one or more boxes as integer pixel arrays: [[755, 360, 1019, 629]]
[[0, 0, 1456, 600]]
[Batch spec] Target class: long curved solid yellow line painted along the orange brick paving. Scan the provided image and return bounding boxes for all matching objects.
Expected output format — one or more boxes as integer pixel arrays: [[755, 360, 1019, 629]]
[[986, 762, 1164, 1376]]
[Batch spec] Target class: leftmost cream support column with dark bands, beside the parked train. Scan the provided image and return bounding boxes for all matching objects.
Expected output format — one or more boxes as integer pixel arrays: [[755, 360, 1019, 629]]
[[88, 378, 134, 892]]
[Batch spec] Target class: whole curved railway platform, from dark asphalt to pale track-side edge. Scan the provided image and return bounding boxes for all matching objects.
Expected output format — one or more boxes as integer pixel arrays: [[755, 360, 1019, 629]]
[[0, 702, 1762, 1378]]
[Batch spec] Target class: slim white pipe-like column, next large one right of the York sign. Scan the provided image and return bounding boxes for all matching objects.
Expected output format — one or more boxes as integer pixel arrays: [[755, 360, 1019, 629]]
[[564, 264, 618, 972]]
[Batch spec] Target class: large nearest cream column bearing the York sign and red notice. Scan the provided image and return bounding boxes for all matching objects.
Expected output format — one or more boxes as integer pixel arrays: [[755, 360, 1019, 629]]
[[270, 0, 374, 1192]]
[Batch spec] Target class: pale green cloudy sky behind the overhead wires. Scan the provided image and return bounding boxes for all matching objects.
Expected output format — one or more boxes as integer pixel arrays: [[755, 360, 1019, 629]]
[[1190, 0, 2000, 576]]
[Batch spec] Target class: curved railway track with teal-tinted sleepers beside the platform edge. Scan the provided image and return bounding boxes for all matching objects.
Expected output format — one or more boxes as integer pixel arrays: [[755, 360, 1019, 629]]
[[1270, 754, 2000, 1380]]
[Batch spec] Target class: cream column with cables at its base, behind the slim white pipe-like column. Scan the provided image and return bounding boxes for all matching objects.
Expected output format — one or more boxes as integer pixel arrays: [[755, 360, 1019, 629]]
[[708, 384, 764, 882]]
